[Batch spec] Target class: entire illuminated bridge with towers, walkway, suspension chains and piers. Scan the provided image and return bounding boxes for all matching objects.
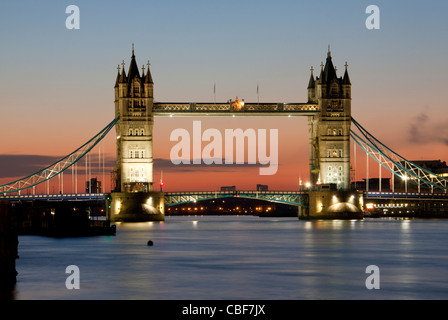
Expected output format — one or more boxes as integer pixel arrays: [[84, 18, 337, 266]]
[[0, 48, 447, 221]]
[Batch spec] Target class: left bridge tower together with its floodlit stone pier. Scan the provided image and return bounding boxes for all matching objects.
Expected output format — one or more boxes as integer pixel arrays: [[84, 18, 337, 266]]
[[110, 45, 164, 221]]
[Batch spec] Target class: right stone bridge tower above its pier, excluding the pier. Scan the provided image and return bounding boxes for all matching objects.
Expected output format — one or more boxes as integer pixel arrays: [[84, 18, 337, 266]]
[[308, 48, 351, 190]]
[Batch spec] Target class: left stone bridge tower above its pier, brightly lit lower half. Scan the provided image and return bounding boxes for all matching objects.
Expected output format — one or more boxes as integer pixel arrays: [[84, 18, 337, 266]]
[[115, 44, 154, 192]]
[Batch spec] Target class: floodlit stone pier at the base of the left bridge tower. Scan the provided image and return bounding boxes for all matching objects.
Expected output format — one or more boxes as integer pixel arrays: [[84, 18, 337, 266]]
[[108, 192, 165, 222]]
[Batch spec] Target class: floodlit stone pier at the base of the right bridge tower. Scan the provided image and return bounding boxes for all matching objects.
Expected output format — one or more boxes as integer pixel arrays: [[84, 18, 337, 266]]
[[298, 190, 364, 220]]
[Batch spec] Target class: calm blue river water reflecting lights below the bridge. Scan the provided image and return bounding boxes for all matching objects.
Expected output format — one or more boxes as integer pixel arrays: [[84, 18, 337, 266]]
[[15, 216, 448, 300]]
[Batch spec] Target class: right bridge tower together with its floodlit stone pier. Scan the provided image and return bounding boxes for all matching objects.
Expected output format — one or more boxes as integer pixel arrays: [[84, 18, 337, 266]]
[[299, 46, 363, 219]]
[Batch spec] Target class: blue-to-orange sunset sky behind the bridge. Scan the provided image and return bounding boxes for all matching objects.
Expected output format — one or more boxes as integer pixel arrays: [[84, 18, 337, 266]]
[[0, 0, 448, 192]]
